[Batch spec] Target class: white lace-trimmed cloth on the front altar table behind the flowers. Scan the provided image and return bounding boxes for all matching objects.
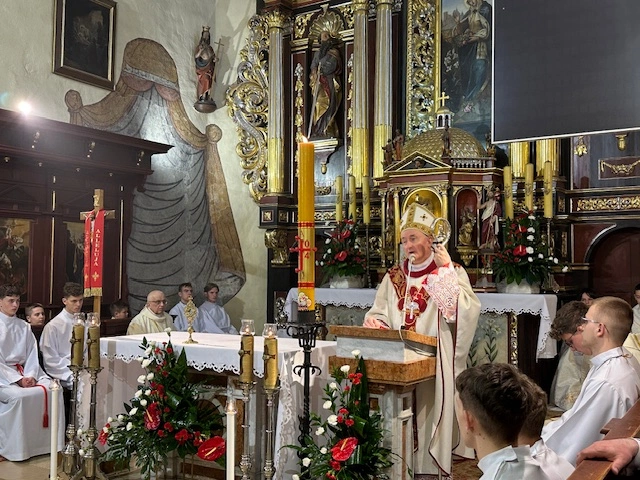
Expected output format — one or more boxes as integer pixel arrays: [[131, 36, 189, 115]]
[[97, 332, 336, 480]]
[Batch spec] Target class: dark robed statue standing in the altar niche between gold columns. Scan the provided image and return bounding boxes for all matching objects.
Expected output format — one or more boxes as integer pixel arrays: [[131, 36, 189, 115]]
[[309, 30, 342, 138]]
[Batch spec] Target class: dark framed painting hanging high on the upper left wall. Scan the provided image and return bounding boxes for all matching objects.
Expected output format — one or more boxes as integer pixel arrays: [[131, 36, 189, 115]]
[[53, 0, 116, 90]]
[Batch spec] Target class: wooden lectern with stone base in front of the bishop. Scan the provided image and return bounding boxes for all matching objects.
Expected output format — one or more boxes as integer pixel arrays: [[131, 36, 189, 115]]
[[329, 325, 437, 480]]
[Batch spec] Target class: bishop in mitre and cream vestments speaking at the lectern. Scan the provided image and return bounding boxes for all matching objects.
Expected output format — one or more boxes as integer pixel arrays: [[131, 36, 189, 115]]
[[363, 203, 480, 474]]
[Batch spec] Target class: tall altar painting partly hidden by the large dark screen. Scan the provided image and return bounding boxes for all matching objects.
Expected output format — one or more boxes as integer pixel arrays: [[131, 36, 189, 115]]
[[440, 0, 493, 144]]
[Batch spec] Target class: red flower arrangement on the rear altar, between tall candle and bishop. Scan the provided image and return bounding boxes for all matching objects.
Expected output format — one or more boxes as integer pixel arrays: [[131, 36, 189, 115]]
[[316, 220, 367, 282]]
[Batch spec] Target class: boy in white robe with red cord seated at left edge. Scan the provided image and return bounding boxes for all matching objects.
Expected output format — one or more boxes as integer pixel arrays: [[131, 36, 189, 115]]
[[0, 285, 64, 461]]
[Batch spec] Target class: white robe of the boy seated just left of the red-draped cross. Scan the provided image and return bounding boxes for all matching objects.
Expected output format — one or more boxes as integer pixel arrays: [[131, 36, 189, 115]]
[[40, 310, 76, 388]]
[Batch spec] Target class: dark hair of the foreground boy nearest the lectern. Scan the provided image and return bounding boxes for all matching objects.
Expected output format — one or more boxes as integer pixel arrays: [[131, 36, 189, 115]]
[[456, 363, 530, 444]]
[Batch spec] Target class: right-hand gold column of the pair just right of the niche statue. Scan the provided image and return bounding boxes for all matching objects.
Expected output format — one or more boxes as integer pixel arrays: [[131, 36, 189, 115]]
[[373, 0, 392, 177]]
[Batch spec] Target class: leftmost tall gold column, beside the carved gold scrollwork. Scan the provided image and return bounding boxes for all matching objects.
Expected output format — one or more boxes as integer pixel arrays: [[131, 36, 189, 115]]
[[265, 10, 286, 193]]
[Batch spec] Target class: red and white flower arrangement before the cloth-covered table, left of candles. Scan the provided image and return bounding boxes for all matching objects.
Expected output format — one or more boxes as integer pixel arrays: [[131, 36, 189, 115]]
[[98, 332, 225, 479]]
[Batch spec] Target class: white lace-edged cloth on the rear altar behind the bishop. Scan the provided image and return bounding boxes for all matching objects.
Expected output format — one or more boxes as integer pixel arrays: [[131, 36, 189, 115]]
[[284, 288, 558, 360]]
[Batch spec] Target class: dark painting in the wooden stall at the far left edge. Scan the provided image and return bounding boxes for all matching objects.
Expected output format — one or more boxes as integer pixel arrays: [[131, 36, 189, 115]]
[[0, 218, 31, 297]]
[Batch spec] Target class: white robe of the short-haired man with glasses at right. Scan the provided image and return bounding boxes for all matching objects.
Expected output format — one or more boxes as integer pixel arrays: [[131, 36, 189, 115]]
[[542, 347, 640, 465]]
